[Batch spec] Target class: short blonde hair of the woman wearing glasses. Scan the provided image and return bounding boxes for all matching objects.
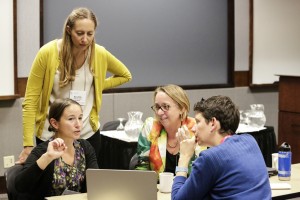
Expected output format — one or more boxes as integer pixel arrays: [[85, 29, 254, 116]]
[[153, 84, 190, 121]]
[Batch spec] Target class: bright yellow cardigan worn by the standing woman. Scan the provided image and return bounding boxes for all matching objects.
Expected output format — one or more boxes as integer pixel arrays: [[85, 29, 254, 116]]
[[22, 40, 132, 146]]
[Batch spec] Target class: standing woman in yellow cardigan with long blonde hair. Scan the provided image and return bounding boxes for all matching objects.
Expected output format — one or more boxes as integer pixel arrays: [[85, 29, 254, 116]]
[[19, 8, 132, 166]]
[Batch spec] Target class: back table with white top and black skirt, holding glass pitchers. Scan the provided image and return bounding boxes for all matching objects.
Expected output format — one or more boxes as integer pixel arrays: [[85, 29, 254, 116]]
[[99, 126, 277, 170]]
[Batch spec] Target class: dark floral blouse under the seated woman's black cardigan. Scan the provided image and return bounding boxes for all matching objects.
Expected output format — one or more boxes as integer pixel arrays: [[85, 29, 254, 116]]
[[52, 141, 86, 195]]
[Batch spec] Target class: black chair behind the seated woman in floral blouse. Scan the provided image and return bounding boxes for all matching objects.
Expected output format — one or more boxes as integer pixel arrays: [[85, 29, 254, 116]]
[[4, 164, 30, 200]]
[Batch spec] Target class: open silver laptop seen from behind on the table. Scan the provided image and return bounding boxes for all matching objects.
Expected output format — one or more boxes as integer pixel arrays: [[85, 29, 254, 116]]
[[86, 169, 157, 200]]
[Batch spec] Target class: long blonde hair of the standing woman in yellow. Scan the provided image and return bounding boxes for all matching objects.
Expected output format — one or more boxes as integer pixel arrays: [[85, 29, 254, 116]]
[[59, 8, 98, 87]]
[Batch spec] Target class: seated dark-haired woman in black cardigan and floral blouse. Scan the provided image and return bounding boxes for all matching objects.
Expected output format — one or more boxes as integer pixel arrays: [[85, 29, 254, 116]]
[[16, 99, 98, 200]]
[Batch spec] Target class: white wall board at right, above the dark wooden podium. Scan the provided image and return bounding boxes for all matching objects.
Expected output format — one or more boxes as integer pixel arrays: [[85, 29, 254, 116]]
[[252, 0, 300, 84]]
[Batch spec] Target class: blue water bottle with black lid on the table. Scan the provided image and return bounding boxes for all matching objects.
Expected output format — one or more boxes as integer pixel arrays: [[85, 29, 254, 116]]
[[278, 142, 292, 181]]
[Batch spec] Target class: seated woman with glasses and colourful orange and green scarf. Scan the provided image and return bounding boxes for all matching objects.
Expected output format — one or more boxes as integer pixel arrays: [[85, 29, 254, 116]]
[[136, 85, 196, 174]]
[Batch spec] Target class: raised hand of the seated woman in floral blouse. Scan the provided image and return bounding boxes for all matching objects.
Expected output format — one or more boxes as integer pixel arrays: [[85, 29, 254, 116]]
[[47, 138, 67, 159]]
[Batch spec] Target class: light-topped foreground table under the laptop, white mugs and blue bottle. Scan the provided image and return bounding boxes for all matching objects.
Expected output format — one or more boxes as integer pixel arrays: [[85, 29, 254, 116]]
[[46, 163, 300, 200]]
